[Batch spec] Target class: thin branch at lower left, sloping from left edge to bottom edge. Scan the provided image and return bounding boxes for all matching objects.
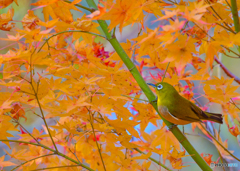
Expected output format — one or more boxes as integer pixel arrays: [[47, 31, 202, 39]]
[[0, 139, 94, 171]]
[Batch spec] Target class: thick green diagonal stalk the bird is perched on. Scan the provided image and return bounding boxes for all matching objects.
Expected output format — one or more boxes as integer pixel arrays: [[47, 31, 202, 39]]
[[87, 0, 212, 171]]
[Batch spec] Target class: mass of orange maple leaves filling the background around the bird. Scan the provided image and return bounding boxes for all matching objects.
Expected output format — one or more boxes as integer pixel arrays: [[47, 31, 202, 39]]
[[0, 0, 240, 171]]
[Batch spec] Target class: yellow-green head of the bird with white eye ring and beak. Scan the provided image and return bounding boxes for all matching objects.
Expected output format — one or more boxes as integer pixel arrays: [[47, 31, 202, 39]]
[[147, 82, 178, 98]]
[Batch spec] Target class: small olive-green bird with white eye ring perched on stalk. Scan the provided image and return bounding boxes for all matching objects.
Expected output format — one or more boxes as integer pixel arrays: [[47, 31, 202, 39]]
[[148, 82, 223, 125]]
